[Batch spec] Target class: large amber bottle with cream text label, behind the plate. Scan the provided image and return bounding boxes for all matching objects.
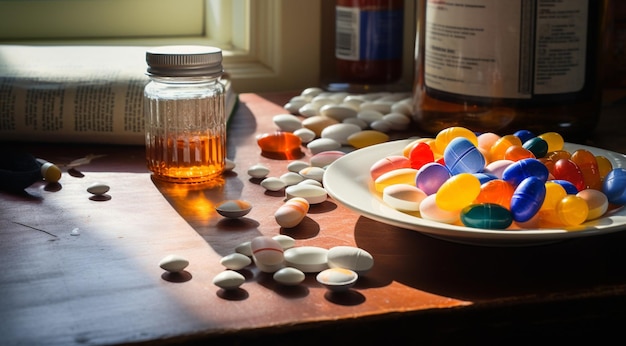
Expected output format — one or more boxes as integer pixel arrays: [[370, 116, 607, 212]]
[[413, 0, 610, 141]]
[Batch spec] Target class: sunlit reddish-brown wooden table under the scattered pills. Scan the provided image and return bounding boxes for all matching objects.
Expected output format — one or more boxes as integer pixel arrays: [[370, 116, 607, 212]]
[[0, 93, 626, 345]]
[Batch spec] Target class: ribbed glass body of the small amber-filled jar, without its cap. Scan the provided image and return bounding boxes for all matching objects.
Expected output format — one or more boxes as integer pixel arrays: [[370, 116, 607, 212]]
[[145, 85, 226, 183]]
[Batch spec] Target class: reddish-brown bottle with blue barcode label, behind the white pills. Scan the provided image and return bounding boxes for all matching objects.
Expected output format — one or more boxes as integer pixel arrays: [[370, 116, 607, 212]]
[[335, 0, 404, 84]]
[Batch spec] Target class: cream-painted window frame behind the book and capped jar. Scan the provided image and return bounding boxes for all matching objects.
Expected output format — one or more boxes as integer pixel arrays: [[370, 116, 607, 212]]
[[0, 0, 322, 92]]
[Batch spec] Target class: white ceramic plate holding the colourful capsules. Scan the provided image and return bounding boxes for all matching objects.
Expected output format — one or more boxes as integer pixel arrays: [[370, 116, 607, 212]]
[[324, 139, 626, 246]]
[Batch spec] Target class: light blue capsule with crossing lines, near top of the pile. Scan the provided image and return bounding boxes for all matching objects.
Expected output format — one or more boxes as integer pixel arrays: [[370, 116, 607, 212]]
[[443, 137, 485, 175]]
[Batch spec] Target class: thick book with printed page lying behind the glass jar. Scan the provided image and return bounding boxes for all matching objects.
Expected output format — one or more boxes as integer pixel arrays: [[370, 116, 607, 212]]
[[0, 45, 237, 145]]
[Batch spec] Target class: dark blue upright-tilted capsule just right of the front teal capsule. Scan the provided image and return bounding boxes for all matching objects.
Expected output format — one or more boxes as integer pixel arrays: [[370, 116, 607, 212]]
[[511, 177, 546, 222]]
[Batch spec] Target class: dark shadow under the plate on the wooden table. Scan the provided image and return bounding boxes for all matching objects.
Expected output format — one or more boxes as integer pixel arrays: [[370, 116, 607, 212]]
[[355, 217, 626, 301]]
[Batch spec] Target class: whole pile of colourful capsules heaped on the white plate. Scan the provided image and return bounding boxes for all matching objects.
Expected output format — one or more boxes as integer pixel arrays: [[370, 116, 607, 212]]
[[370, 127, 626, 230]]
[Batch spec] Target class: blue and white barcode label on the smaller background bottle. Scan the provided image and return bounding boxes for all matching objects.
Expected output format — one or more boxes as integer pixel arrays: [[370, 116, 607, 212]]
[[335, 6, 404, 61]]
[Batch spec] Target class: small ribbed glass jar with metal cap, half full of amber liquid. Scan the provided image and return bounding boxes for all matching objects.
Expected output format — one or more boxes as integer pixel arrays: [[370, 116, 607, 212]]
[[144, 46, 226, 183]]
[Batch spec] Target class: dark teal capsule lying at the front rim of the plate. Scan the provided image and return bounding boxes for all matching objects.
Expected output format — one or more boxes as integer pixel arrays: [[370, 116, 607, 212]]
[[461, 203, 513, 229]]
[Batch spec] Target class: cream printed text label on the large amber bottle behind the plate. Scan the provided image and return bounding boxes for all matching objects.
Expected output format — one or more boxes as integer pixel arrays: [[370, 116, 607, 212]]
[[424, 0, 589, 99]]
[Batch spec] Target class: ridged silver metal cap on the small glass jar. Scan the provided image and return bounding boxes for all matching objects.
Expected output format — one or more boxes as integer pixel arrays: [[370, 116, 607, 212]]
[[146, 45, 224, 77]]
